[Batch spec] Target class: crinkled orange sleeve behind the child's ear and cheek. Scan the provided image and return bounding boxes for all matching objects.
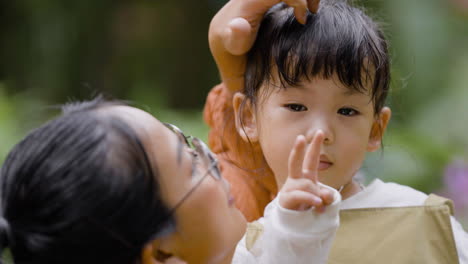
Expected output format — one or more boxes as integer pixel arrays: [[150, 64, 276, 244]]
[[203, 84, 278, 221]]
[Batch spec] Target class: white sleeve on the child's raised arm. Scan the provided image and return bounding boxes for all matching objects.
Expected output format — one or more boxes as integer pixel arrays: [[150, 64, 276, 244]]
[[233, 185, 341, 264]]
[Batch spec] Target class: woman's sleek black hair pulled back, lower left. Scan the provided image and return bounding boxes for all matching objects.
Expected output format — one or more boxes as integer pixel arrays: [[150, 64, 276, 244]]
[[0, 98, 174, 264]]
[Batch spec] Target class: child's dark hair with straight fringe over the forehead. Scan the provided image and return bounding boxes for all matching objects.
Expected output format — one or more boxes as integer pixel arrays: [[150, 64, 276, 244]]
[[244, 0, 390, 114]]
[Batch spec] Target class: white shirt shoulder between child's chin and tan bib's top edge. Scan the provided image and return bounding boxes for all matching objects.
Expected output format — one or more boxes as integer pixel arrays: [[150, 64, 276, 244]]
[[341, 179, 428, 209]]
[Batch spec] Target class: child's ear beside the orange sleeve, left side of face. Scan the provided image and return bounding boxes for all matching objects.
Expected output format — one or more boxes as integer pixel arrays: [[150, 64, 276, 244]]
[[232, 92, 258, 142]]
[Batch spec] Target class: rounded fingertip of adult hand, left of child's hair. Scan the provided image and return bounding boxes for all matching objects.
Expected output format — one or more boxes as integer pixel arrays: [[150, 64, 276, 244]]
[[223, 17, 252, 55]]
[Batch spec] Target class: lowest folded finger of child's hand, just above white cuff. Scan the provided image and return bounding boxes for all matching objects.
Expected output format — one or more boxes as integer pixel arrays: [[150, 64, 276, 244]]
[[281, 190, 323, 210]]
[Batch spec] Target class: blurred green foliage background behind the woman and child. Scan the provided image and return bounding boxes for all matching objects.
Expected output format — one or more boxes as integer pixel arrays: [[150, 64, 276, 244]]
[[0, 0, 468, 226]]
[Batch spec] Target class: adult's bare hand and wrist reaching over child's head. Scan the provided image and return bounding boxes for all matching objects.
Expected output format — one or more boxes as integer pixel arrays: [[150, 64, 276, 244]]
[[209, 0, 320, 91]]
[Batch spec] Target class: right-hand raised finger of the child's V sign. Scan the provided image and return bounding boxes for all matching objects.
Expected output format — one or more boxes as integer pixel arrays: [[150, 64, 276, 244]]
[[302, 130, 324, 183]]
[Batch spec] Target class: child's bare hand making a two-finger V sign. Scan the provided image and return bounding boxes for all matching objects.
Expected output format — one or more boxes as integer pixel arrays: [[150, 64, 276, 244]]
[[279, 130, 333, 212]]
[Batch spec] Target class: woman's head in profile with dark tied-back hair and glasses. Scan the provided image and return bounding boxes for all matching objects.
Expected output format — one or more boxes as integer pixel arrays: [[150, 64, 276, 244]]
[[0, 99, 245, 264]]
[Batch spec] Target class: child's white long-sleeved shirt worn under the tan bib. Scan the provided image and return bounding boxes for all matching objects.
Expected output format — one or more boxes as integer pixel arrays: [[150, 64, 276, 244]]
[[232, 179, 468, 264]]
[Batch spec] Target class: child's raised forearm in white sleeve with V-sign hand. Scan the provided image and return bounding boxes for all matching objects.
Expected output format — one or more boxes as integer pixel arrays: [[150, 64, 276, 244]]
[[232, 130, 341, 264]]
